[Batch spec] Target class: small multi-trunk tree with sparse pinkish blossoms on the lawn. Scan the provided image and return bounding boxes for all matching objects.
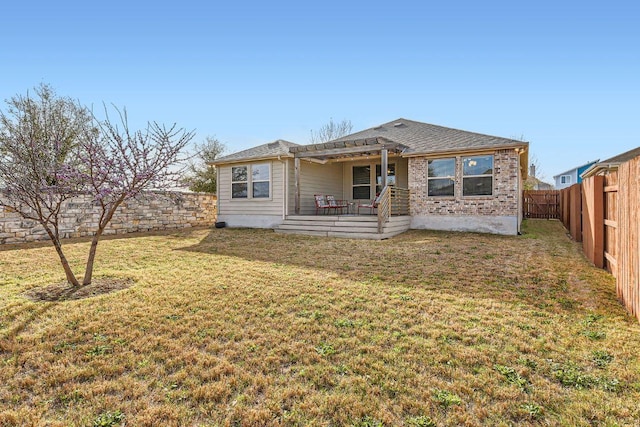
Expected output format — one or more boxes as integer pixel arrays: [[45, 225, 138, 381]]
[[0, 86, 193, 286]]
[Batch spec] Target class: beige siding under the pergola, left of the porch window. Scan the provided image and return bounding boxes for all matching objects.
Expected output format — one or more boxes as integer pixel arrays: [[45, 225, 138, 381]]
[[288, 159, 345, 215]]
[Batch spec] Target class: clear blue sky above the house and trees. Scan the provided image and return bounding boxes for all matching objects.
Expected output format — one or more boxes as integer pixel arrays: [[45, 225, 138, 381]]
[[0, 0, 640, 181]]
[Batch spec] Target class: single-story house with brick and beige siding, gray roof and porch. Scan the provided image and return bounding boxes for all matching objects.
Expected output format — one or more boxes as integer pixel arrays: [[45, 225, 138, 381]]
[[212, 118, 529, 238]]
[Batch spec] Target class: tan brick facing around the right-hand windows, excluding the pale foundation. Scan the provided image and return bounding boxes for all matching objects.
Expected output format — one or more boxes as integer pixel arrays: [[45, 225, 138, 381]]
[[409, 149, 519, 216]]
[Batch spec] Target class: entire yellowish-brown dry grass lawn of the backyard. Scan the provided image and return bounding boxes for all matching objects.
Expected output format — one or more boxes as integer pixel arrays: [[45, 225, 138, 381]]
[[0, 221, 640, 427]]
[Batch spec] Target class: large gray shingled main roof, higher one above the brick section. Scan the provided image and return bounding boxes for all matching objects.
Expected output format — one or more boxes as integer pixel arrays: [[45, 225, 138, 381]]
[[332, 118, 528, 155]]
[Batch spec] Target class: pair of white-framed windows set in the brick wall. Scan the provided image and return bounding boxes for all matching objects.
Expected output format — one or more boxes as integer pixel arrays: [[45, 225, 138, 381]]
[[427, 155, 493, 197]]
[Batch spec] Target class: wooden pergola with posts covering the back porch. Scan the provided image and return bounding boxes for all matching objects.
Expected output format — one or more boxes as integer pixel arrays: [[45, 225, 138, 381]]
[[289, 137, 408, 214]]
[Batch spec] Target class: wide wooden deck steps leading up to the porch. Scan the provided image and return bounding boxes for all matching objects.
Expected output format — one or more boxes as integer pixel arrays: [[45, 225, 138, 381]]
[[275, 215, 411, 240]]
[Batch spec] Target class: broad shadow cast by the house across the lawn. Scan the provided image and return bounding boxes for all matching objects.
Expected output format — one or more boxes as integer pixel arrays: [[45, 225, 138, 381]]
[[174, 229, 604, 313]]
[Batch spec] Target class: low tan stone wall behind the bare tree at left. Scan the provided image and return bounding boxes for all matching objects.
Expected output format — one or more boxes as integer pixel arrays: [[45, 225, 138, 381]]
[[0, 192, 216, 244]]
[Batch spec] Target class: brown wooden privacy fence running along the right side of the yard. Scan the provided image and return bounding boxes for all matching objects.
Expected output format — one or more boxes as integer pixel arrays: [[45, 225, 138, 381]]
[[560, 157, 640, 320]]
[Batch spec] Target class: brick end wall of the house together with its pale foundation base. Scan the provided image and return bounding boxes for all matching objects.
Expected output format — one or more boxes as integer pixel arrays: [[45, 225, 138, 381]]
[[409, 149, 521, 234]]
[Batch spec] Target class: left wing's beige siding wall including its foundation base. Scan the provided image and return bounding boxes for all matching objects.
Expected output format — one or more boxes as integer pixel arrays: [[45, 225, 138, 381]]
[[218, 160, 287, 228]]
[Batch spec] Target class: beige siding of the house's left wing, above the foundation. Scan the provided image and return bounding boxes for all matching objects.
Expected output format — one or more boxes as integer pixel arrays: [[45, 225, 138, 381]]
[[218, 160, 286, 216]]
